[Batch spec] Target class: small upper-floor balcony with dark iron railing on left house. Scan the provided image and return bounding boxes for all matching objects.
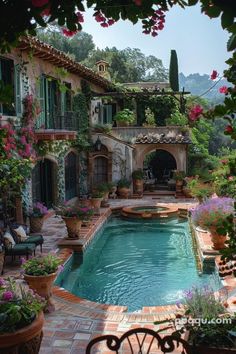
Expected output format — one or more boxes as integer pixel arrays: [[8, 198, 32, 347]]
[[35, 112, 79, 140]]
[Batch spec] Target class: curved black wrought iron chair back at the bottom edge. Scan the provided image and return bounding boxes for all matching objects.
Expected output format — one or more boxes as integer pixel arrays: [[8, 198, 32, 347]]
[[86, 328, 192, 354]]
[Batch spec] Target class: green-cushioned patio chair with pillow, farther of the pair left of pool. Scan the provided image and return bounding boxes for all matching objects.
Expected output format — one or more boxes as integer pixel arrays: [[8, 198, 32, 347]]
[[9, 223, 44, 253]]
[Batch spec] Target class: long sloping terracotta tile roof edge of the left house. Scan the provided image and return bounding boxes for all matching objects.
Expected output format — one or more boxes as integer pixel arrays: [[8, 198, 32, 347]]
[[18, 36, 114, 91]]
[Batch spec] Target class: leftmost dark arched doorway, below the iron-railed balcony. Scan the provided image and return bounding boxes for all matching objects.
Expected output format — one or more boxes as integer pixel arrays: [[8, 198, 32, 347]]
[[32, 158, 56, 208]]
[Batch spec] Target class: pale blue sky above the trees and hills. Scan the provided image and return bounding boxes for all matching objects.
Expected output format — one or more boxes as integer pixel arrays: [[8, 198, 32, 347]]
[[83, 6, 230, 75]]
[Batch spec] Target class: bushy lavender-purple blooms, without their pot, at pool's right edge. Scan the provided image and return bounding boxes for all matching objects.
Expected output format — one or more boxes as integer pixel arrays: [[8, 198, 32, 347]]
[[191, 197, 234, 234]]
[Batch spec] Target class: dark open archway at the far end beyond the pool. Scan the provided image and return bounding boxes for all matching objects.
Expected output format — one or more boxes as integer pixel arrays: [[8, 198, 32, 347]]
[[144, 149, 177, 189]]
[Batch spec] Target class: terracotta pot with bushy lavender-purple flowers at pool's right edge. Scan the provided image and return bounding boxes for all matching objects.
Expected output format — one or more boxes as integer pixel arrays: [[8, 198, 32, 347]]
[[191, 197, 234, 250]]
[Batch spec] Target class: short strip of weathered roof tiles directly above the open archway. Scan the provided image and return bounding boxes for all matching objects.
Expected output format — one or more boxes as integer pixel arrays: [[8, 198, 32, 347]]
[[135, 133, 191, 144]]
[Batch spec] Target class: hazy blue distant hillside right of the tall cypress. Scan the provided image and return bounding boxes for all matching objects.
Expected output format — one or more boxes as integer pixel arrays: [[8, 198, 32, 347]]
[[179, 73, 229, 104]]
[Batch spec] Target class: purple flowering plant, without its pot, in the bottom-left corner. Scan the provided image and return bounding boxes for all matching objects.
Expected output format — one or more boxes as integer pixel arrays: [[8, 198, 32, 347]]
[[0, 278, 45, 335]]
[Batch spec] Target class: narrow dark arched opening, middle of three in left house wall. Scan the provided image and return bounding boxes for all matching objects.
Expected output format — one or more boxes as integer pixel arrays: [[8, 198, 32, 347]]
[[65, 152, 77, 200]]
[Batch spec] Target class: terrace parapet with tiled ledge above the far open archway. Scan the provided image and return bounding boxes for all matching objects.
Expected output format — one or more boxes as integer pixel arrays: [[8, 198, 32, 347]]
[[111, 126, 191, 144]]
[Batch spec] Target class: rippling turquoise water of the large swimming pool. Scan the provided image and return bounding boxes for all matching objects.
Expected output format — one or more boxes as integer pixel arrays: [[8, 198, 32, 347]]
[[56, 218, 219, 311]]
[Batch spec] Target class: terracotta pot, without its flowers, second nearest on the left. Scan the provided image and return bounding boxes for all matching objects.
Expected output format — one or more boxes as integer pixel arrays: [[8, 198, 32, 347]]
[[24, 273, 57, 312]]
